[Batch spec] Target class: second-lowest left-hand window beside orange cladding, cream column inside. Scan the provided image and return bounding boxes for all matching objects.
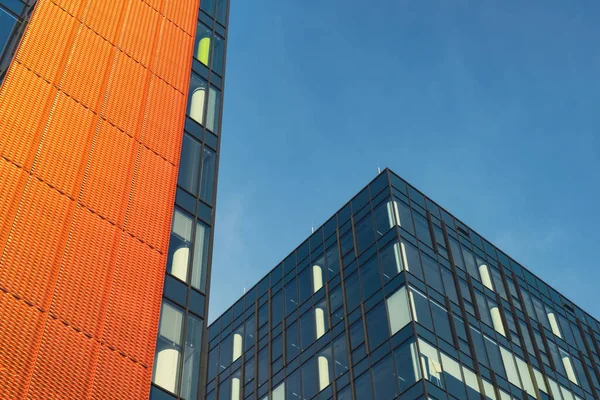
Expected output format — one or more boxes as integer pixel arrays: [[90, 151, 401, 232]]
[[167, 209, 194, 282]]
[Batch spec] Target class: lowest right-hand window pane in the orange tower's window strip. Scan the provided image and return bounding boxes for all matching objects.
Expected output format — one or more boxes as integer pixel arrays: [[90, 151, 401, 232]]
[[181, 315, 202, 400]]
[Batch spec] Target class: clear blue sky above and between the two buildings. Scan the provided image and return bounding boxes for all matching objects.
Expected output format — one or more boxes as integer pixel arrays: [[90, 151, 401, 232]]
[[209, 0, 600, 321]]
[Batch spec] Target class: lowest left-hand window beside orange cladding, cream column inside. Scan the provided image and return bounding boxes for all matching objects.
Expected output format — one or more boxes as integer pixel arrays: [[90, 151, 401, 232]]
[[152, 301, 183, 394]]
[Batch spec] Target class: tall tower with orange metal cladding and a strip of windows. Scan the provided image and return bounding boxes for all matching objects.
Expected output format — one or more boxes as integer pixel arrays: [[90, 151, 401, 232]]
[[0, 0, 228, 399]]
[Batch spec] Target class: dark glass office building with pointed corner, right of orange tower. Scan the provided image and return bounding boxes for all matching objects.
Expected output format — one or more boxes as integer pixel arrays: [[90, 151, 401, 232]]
[[206, 170, 600, 400]]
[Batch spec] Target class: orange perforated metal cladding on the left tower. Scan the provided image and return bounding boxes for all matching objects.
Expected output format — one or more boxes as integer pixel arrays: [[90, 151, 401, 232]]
[[0, 0, 199, 400]]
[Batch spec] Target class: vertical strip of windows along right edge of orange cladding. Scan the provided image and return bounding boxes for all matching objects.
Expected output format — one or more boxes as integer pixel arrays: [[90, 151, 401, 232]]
[[150, 0, 228, 400]]
